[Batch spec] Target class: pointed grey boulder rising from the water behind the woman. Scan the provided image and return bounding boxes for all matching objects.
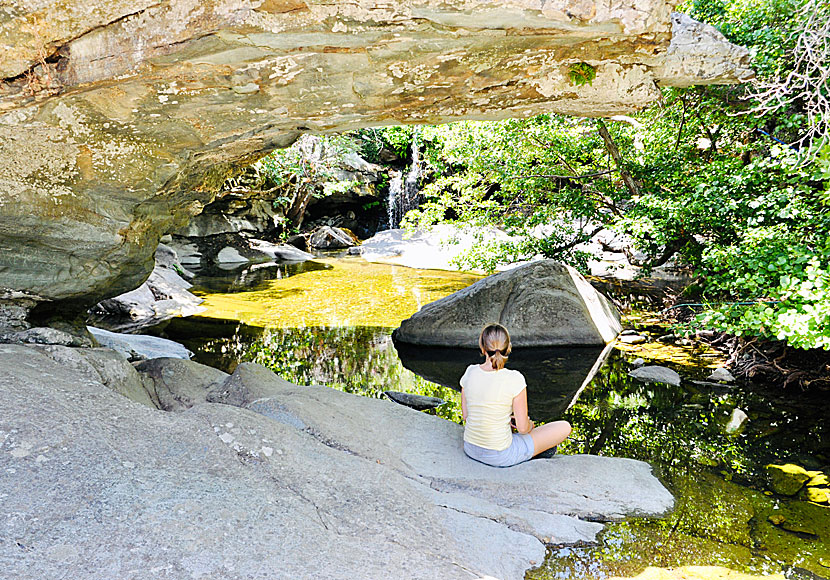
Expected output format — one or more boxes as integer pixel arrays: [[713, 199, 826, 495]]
[[393, 260, 622, 348]]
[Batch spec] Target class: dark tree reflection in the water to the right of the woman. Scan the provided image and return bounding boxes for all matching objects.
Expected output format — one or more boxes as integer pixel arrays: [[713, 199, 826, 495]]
[[568, 352, 827, 485]]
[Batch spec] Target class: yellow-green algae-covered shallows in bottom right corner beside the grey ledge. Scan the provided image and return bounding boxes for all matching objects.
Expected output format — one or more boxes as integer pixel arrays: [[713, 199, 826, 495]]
[[526, 471, 830, 580]]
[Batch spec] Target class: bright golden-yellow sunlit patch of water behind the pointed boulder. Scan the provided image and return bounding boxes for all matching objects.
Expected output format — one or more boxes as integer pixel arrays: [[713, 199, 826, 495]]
[[196, 258, 482, 328]]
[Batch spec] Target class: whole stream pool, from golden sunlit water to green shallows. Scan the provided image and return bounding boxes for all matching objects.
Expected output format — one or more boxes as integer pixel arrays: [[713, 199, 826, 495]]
[[154, 257, 830, 580]]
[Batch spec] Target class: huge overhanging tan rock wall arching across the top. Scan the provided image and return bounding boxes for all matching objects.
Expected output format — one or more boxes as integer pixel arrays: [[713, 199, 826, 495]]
[[0, 0, 751, 326]]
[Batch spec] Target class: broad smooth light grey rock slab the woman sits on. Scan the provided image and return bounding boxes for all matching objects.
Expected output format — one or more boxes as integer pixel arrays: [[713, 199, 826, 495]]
[[0, 345, 673, 580]]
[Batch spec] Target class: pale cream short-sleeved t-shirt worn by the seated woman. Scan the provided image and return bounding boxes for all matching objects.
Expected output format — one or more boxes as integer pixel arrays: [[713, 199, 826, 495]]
[[461, 365, 527, 451]]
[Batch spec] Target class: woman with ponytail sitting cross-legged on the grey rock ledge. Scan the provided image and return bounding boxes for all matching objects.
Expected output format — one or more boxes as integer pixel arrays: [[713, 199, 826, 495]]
[[461, 324, 571, 467]]
